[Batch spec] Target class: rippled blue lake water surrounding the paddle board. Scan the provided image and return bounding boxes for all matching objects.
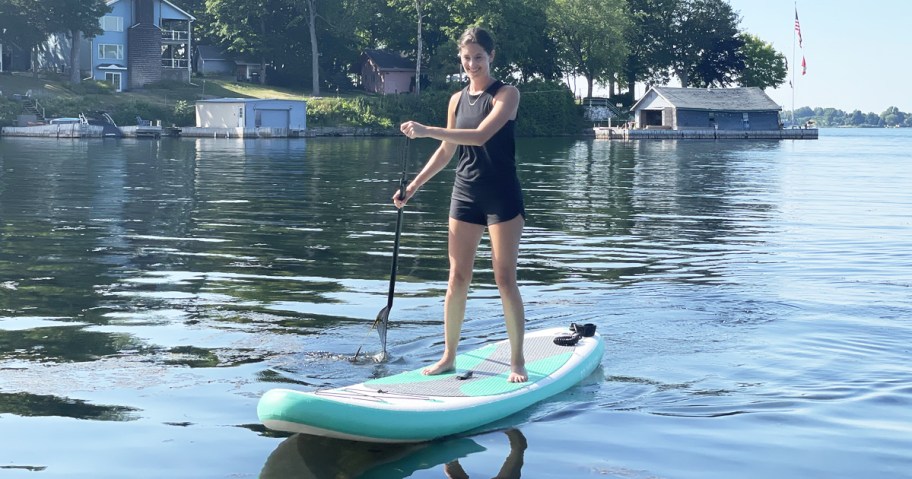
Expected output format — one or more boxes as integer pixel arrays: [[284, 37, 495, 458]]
[[0, 130, 912, 479]]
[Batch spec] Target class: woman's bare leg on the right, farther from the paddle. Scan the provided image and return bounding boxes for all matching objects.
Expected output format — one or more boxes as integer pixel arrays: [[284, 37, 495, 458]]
[[488, 215, 529, 383]]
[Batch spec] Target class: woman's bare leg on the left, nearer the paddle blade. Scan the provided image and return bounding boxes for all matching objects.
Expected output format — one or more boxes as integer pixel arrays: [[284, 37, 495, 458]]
[[424, 218, 484, 375]]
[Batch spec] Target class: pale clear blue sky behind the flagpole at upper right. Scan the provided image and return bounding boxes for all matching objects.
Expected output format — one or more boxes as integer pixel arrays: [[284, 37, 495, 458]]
[[728, 0, 912, 114]]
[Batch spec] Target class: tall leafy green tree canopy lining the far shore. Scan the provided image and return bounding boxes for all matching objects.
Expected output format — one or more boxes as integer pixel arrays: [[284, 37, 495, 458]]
[[0, 0, 787, 105]]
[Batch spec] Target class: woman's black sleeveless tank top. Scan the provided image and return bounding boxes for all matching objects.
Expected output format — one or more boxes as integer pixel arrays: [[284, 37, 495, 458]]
[[453, 80, 520, 200]]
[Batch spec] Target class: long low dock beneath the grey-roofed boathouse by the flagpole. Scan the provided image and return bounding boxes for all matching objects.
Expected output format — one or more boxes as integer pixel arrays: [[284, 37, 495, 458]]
[[593, 126, 818, 140]]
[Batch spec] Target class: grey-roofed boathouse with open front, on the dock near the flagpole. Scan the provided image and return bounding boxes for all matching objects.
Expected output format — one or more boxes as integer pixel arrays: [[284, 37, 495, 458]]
[[631, 86, 782, 131]]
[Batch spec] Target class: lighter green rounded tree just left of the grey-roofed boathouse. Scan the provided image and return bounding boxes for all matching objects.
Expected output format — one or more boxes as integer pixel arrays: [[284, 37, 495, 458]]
[[548, 0, 629, 96]]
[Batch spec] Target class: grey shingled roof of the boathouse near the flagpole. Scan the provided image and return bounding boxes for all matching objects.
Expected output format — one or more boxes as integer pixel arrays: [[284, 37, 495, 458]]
[[631, 86, 782, 111]]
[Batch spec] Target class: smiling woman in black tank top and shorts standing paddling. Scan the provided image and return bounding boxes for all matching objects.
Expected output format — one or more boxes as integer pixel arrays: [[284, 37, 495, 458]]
[[393, 28, 528, 382]]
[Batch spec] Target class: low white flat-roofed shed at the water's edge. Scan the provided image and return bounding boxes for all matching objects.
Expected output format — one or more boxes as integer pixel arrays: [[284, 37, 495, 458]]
[[196, 98, 307, 131]]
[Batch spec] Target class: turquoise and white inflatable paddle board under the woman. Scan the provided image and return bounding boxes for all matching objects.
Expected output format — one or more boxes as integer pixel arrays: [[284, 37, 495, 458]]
[[257, 324, 604, 443]]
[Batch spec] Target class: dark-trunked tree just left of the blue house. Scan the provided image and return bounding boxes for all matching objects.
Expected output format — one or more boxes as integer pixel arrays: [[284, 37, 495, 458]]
[[41, 0, 111, 84]]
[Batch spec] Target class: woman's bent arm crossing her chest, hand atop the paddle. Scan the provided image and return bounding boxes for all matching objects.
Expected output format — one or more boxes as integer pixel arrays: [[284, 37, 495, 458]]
[[399, 85, 519, 146]]
